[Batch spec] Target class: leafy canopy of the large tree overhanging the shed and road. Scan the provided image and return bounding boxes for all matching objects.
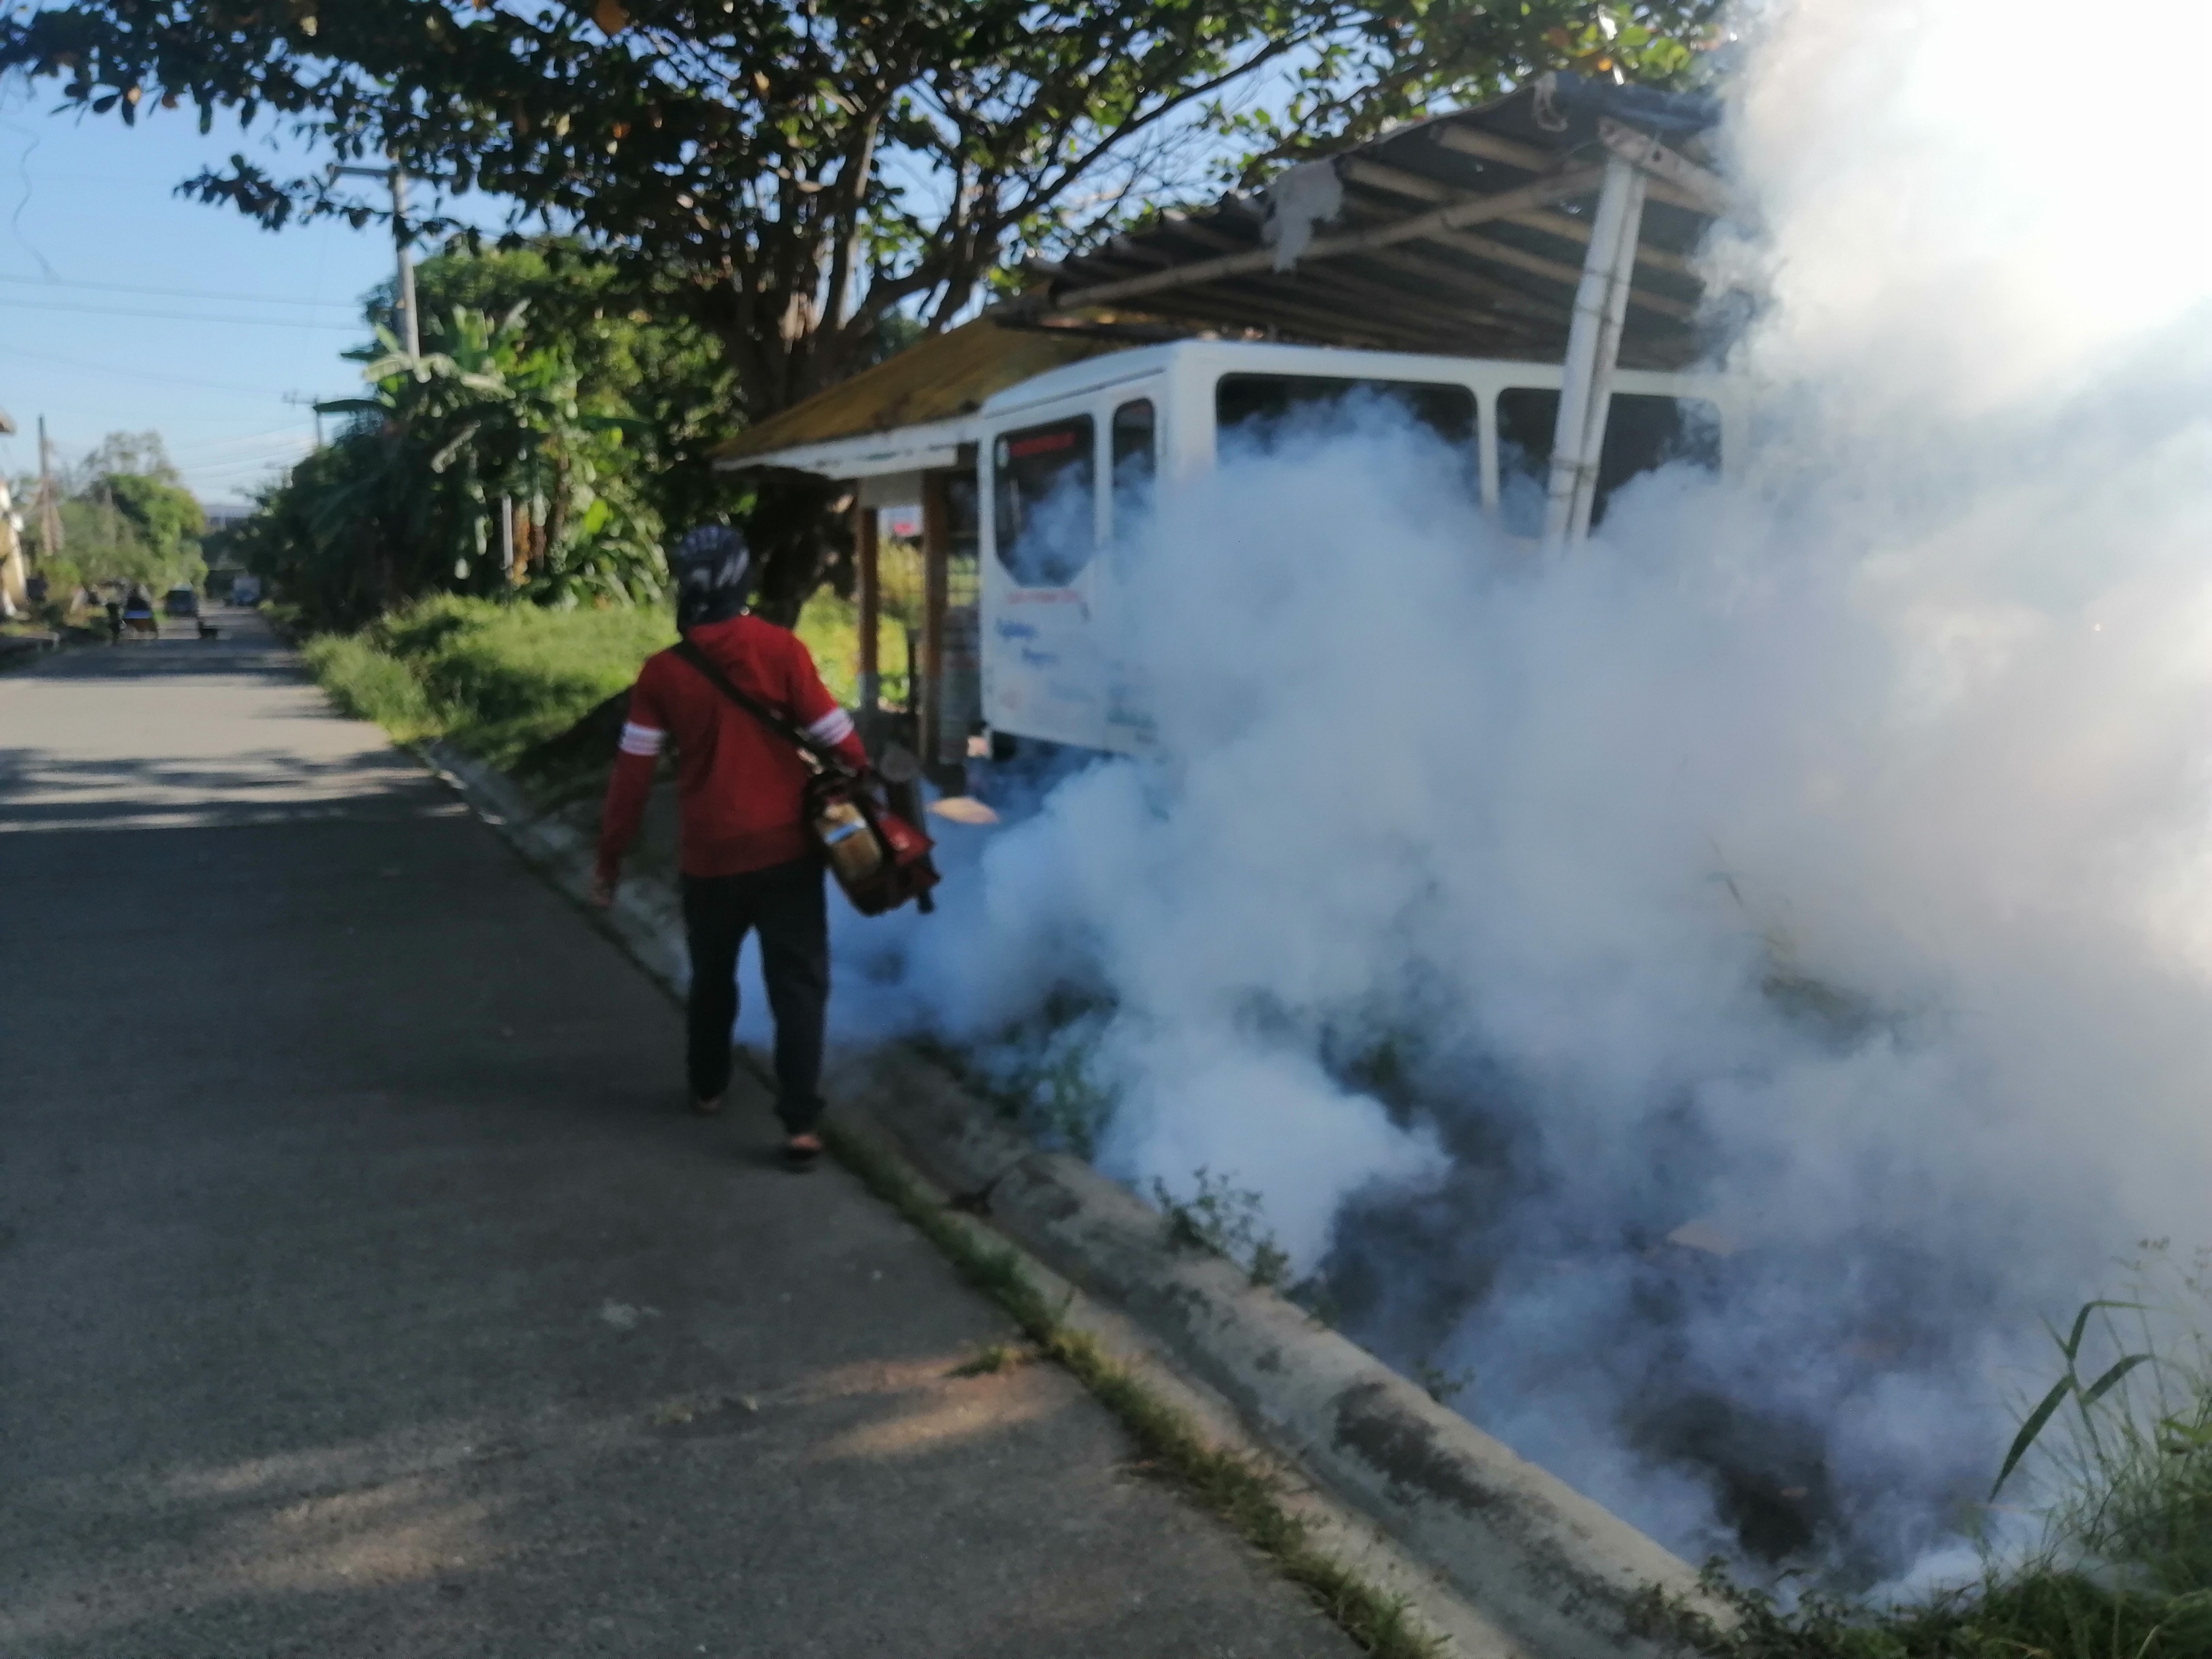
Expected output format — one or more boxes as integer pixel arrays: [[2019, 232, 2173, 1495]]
[[0, 0, 1719, 418]]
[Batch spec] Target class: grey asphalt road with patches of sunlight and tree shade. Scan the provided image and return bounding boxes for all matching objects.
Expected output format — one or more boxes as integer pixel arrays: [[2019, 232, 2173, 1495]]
[[0, 615, 1351, 1659]]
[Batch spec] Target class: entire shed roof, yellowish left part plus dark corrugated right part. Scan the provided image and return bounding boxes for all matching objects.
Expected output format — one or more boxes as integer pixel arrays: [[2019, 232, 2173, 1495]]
[[717, 73, 1719, 467]]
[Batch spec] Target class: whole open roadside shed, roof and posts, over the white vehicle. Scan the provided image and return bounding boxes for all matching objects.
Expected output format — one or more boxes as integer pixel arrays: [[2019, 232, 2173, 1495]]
[[719, 70, 1734, 765]]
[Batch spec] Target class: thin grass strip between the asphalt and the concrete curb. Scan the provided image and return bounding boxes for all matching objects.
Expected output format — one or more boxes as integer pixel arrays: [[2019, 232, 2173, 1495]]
[[825, 1124, 1442, 1659]]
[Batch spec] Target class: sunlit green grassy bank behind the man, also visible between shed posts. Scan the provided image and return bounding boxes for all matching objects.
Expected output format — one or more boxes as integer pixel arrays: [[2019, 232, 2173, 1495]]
[[303, 593, 903, 765]]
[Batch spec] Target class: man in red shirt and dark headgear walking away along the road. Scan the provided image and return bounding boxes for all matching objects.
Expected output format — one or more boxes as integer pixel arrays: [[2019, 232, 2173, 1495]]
[[593, 525, 867, 1168]]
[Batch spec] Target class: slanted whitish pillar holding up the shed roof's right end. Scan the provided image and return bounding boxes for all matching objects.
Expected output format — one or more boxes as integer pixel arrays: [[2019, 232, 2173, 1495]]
[[1544, 155, 1643, 553]]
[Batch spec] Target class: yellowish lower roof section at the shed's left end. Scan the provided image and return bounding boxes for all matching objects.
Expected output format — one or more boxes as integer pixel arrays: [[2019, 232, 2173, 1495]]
[[714, 316, 1128, 467]]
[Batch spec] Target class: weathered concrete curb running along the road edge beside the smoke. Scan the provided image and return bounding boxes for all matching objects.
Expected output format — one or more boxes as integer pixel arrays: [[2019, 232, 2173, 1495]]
[[425, 743, 1734, 1659]]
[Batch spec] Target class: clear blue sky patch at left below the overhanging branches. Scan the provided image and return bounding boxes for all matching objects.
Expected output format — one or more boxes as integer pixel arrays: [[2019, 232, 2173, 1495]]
[[0, 82, 422, 502]]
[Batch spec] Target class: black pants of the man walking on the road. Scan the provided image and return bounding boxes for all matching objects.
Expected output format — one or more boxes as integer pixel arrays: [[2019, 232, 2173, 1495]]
[[684, 858, 830, 1134]]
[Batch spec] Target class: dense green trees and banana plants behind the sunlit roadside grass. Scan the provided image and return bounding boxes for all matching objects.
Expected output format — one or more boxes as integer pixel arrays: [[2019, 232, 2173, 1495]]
[[224, 241, 745, 626]]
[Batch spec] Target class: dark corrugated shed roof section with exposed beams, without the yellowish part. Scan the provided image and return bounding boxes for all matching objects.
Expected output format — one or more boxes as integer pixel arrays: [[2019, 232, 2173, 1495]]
[[1002, 73, 1719, 367]]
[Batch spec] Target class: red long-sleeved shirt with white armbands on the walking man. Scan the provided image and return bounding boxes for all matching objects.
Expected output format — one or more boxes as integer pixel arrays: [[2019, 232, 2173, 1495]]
[[600, 617, 867, 880]]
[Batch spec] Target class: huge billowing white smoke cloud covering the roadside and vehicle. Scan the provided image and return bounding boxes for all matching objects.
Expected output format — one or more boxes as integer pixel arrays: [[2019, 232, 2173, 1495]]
[[809, 0, 2212, 1577]]
